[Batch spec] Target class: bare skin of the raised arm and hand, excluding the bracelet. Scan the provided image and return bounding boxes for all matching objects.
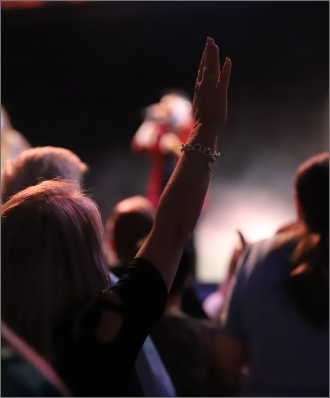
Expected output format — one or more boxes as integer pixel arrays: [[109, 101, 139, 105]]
[[136, 38, 231, 290]]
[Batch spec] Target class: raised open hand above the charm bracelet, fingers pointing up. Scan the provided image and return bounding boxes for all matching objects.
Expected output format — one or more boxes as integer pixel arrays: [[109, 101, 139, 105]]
[[193, 37, 231, 132]]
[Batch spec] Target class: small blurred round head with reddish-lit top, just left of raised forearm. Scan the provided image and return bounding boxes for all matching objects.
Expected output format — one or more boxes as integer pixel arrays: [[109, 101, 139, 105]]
[[106, 196, 154, 262]]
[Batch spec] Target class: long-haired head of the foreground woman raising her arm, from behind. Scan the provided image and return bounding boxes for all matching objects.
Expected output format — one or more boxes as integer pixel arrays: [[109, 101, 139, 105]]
[[1, 180, 109, 359]]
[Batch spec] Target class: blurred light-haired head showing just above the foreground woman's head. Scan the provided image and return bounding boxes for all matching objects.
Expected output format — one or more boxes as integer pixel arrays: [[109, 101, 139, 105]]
[[1, 146, 88, 202]]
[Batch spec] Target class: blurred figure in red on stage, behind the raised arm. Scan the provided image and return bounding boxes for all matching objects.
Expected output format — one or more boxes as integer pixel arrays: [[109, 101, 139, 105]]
[[132, 92, 194, 207]]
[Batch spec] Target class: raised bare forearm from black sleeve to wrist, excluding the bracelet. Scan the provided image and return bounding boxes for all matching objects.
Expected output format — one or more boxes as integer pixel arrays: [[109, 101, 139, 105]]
[[137, 121, 220, 289]]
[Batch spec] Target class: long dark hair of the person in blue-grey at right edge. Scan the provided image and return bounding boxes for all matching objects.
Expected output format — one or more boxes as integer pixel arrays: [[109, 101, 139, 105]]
[[288, 152, 329, 328]]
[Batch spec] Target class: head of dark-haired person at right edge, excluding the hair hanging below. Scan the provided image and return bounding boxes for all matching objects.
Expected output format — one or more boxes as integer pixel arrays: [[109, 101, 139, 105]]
[[294, 152, 329, 234]]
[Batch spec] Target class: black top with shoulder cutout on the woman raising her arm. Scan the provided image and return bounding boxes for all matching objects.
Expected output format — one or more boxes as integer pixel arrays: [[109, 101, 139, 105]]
[[54, 259, 167, 397]]
